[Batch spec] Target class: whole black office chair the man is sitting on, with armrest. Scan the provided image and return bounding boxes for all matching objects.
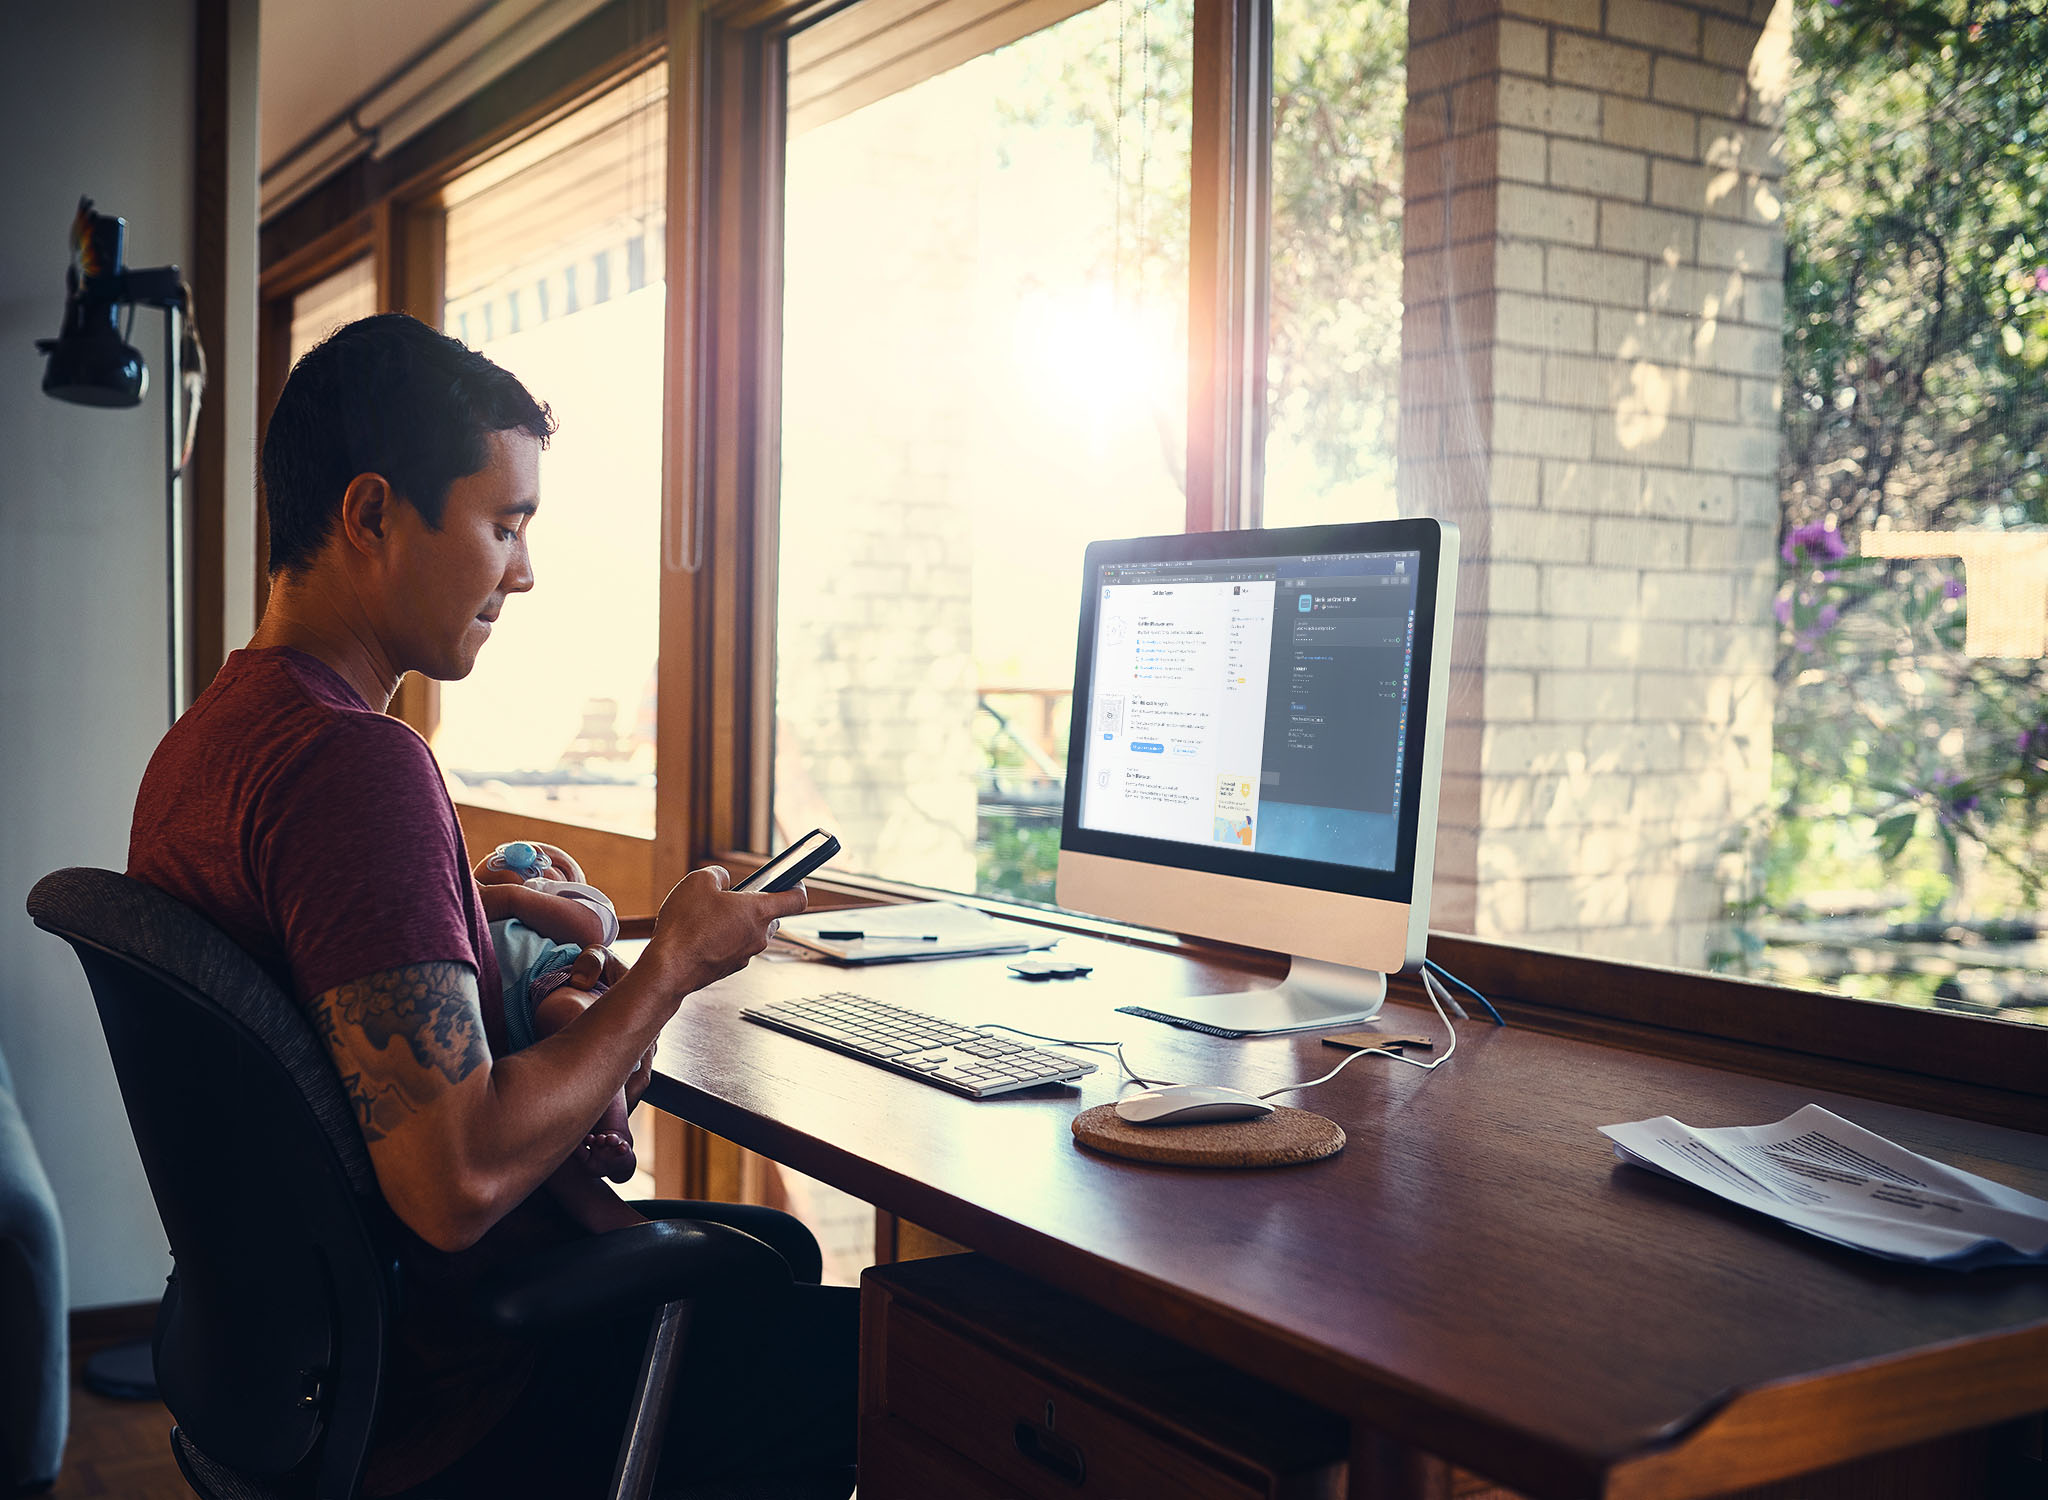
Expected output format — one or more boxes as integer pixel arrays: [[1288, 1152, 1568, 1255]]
[[29, 869, 852, 1500]]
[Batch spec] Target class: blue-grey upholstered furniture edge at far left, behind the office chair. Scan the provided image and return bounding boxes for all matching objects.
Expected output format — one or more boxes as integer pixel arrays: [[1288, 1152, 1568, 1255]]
[[0, 1036, 72, 1494]]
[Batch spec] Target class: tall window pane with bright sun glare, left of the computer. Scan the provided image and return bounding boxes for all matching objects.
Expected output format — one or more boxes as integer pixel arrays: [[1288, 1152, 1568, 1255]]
[[774, 0, 1192, 900]]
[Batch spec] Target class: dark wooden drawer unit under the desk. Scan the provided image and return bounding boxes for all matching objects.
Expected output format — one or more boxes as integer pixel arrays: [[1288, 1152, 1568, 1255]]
[[860, 1256, 1346, 1500]]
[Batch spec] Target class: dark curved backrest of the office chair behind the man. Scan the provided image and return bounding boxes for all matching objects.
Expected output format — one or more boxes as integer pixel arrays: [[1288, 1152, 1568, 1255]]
[[29, 869, 395, 1500]]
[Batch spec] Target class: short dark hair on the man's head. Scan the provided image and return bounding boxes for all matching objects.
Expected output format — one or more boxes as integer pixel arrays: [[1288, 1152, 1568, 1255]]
[[262, 314, 555, 574]]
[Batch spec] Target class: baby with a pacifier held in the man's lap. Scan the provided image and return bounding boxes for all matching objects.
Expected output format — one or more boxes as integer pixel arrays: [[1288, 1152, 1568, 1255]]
[[473, 842, 639, 1227]]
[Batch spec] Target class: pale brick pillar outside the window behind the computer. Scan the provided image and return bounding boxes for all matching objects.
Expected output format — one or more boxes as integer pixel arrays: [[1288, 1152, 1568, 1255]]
[[1401, 0, 1790, 967]]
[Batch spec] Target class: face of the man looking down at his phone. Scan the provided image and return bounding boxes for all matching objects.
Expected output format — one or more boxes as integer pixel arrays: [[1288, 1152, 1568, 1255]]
[[389, 428, 541, 682]]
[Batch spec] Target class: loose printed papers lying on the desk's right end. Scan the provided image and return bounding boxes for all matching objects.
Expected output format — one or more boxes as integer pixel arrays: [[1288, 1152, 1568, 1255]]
[[1599, 1105, 2048, 1270]]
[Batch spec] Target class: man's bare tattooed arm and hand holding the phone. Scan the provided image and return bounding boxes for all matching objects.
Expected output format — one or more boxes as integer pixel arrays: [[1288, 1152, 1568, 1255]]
[[313, 869, 803, 1250]]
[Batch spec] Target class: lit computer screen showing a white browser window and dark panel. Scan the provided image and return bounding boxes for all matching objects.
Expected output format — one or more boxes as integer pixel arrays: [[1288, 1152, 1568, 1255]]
[[1079, 551, 1421, 871]]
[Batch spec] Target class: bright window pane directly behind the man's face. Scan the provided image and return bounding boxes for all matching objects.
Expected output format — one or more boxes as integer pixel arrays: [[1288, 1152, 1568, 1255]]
[[434, 70, 666, 838]]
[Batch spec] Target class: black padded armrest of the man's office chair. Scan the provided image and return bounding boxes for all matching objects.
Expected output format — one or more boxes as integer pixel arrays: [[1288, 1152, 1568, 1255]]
[[477, 1219, 791, 1336]]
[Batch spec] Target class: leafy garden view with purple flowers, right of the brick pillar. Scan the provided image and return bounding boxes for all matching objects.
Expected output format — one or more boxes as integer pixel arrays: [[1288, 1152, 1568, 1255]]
[[1729, 4, 2048, 1020]]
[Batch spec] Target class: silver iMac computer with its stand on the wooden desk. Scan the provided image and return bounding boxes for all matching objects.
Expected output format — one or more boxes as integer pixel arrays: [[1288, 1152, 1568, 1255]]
[[1059, 518, 1458, 1033]]
